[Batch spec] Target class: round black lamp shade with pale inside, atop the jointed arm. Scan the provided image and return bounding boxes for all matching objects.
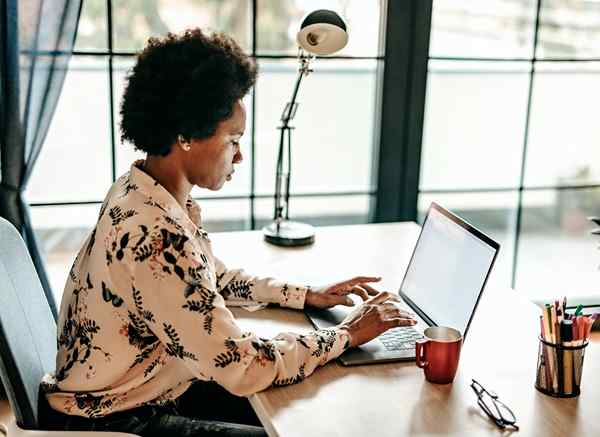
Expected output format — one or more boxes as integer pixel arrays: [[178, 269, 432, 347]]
[[296, 9, 348, 55]]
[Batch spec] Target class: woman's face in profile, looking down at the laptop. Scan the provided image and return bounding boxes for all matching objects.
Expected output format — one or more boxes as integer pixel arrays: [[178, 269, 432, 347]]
[[184, 101, 246, 191]]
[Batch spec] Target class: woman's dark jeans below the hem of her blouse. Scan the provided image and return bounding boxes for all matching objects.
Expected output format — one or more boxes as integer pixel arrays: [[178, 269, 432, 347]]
[[40, 381, 267, 437]]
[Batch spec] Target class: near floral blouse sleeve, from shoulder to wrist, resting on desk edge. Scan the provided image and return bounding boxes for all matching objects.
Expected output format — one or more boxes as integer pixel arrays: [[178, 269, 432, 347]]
[[127, 221, 349, 396]]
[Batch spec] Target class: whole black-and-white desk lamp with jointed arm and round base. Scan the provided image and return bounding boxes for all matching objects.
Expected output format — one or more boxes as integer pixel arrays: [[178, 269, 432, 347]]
[[263, 9, 348, 246]]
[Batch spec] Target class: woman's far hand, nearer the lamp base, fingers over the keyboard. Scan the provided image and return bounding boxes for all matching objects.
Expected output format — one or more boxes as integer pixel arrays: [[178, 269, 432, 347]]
[[305, 276, 381, 308]]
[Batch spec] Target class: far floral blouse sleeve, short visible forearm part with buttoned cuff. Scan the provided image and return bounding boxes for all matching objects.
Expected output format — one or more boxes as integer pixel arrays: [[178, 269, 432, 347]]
[[214, 257, 310, 309]]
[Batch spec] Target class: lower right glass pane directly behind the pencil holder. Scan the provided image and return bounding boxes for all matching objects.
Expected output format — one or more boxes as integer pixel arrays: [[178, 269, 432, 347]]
[[516, 189, 600, 300]]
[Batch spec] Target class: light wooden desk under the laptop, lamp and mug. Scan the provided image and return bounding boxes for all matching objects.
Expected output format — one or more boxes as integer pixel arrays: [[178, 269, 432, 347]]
[[211, 223, 600, 437]]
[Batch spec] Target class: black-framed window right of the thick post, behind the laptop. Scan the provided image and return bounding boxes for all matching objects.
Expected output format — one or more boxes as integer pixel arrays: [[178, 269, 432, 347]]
[[419, 0, 600, 299]]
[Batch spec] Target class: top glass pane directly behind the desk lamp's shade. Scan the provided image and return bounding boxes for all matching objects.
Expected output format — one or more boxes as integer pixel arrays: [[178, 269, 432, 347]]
[[256, 0, 382, 56]]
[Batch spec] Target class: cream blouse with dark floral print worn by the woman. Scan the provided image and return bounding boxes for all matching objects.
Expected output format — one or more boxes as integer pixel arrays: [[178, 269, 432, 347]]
[[43, 160, 349, 417]]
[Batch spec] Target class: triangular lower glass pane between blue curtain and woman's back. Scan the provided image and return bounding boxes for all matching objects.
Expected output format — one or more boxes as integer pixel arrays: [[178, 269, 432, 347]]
[[31, 203, 101, 304]]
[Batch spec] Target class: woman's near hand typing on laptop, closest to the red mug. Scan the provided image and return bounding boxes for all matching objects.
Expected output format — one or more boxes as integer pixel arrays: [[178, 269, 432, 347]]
[[339, 291, 417, 347]]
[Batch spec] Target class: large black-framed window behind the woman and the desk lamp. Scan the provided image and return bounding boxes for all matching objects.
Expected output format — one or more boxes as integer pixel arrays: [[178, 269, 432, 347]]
[[27, 0, 385, 298]]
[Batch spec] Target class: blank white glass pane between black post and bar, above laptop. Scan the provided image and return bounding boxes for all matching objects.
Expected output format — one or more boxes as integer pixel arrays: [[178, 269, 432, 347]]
[[420, 61, 529, 189]]
